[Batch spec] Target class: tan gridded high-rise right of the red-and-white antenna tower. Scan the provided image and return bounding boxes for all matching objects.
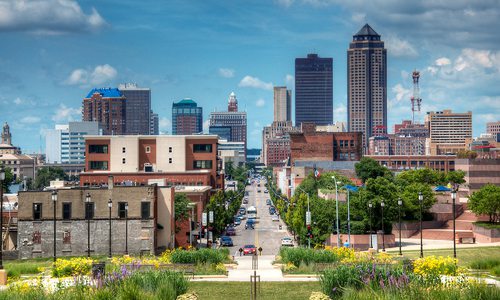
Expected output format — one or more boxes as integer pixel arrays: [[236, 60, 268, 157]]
[[425, 110, 472, 155]]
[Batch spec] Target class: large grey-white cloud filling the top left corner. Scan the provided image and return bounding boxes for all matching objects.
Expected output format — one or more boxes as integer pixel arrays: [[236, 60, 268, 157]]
[[0, 0, 107, 35]]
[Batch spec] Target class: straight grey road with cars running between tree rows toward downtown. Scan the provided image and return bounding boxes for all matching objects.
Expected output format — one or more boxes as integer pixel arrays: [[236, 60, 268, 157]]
[[225, 180, 289, 256]]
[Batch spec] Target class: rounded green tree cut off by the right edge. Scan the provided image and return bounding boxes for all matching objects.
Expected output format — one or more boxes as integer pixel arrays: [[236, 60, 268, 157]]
[[469, 184, 500, 223]]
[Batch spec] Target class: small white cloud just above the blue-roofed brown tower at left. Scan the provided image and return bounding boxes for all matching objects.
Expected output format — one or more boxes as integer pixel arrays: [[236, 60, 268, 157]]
[[64, 64, 118, 86]]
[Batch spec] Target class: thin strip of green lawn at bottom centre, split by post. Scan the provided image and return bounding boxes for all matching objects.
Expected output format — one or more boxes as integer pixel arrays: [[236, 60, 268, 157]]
[[189, 281, 321, 300]]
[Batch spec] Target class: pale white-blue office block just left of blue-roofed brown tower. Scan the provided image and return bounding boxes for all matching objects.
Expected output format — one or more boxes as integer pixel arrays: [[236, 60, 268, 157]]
[[45, 122, 102, 164]]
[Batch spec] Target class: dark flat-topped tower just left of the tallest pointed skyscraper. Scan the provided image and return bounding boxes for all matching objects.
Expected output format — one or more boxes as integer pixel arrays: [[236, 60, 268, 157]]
[[295, 54, 333, 126]]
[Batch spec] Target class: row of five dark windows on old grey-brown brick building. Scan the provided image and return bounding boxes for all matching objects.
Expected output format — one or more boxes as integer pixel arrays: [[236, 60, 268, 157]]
[[33, 202, 151, 220]]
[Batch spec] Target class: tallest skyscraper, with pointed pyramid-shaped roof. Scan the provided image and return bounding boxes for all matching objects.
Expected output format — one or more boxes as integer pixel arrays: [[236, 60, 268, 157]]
[[347, 24, 387, 153]]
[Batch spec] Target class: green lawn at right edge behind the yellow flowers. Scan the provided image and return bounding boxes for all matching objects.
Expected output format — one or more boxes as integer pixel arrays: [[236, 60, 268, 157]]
[[389, 247, 500, 267]]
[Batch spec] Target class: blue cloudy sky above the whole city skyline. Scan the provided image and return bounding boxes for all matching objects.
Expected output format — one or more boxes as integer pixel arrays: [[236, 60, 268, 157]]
[[0, 0, 500, 152]]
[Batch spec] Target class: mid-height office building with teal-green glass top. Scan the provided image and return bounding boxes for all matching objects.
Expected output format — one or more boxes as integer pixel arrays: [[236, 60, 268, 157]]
[[172, 98, 203, 135]]
